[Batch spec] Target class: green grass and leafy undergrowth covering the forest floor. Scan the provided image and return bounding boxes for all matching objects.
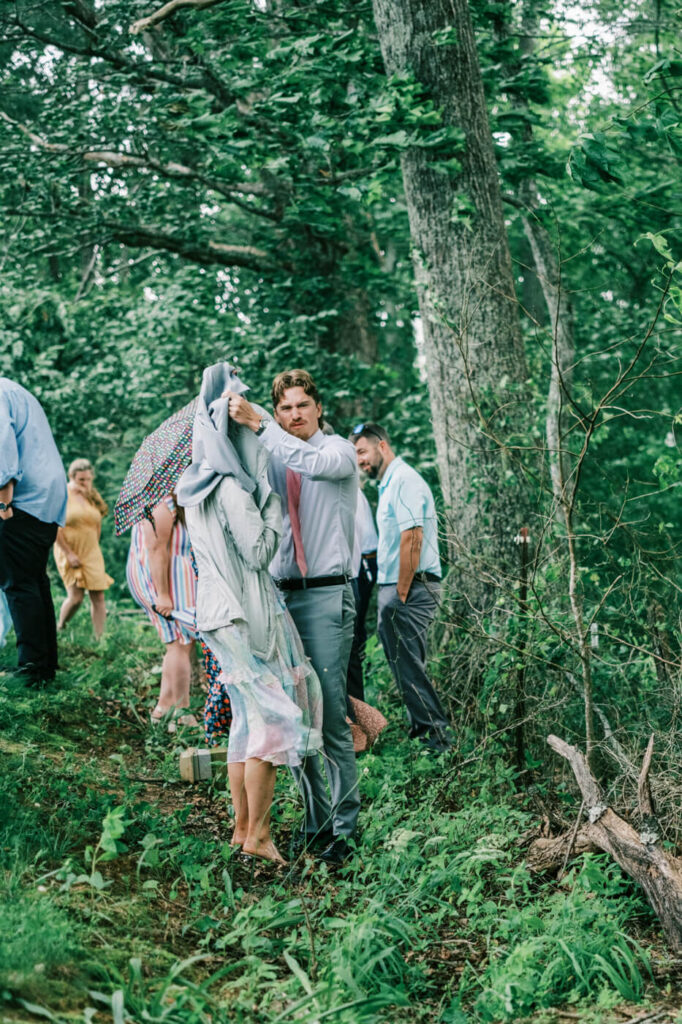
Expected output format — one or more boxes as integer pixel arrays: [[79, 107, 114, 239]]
[[0, 609, 659, 1024]]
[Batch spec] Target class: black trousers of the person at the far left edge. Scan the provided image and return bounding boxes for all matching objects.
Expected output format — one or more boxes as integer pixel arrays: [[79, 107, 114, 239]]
[[0, 509, 57, 679]]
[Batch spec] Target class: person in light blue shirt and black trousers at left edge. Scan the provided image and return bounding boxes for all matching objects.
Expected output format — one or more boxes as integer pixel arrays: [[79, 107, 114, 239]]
[[0, 377, 67, 685]]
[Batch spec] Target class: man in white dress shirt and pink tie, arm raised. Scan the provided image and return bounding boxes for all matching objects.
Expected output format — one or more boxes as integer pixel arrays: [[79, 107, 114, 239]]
[[229, 370, 359, 864]]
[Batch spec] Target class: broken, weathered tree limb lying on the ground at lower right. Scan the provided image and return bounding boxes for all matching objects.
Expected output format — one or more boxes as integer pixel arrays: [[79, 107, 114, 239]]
[[547, 736, 682, 952]]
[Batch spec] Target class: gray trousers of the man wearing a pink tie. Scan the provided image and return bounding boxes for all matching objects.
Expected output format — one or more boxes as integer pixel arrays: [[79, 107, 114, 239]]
[[285, 584, 359, 836]]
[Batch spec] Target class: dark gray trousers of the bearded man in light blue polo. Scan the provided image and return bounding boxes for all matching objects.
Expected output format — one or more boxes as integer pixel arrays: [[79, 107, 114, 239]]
[[379, 582, 450, 737]]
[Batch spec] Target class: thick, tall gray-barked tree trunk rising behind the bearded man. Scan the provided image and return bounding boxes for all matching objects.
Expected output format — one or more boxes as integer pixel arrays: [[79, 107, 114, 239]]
[[374, 0, 528, 604]]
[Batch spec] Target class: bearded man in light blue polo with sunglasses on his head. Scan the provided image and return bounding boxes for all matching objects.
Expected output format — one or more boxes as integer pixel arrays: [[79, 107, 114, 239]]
[[351, 423, 452, 752]]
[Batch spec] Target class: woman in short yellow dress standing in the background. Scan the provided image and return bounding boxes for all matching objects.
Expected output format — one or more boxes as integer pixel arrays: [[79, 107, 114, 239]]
[[54, 459, 114, 640]]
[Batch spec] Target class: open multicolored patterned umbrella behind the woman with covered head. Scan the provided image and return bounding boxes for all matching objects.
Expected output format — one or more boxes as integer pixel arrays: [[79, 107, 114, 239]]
[[114, 398, 198, 537]]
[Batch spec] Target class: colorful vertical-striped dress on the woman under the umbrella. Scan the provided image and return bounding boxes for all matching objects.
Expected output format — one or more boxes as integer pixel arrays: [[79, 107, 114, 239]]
[[126, 495, 197, 644]]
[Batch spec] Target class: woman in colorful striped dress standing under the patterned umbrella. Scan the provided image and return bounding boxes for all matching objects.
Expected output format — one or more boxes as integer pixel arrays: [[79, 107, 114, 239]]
[[126, 495, 198, 732]]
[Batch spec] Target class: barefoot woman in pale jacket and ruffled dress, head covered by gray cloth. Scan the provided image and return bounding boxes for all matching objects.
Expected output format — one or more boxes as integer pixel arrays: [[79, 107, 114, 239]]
[[177, 364, 322, 864]]
